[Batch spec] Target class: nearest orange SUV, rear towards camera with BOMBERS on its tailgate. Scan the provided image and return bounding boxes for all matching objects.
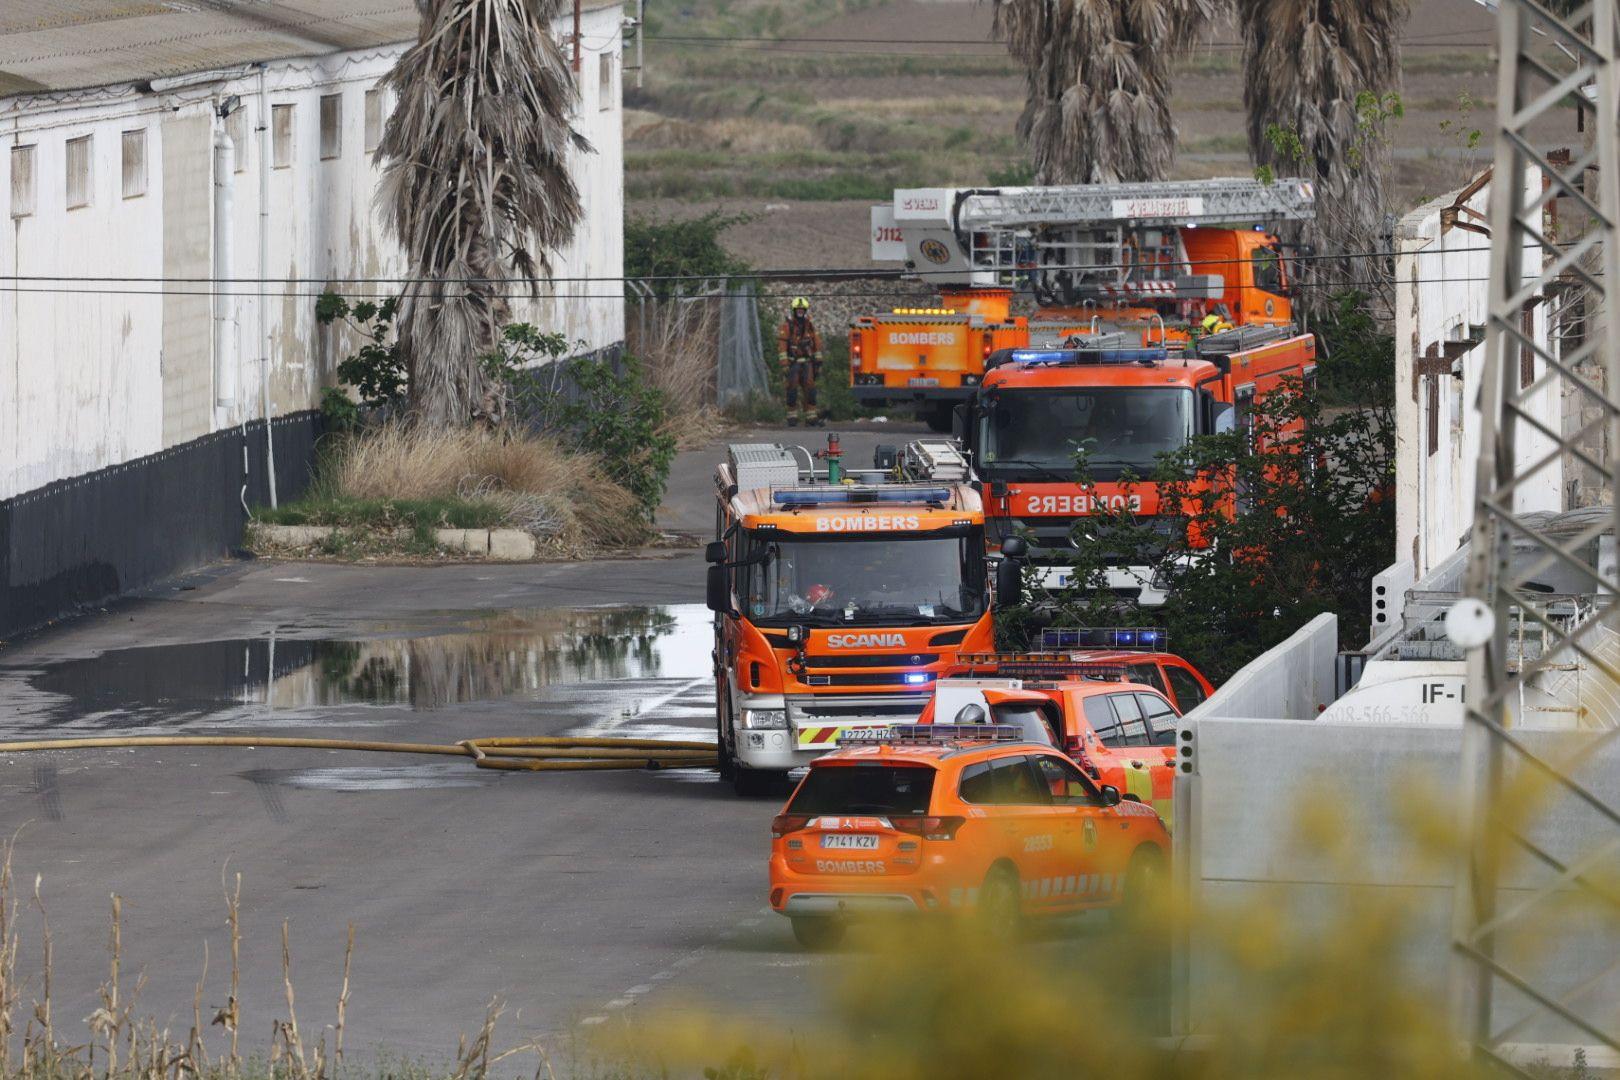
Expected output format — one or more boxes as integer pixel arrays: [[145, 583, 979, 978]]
[[771, 724, 1170, 947]]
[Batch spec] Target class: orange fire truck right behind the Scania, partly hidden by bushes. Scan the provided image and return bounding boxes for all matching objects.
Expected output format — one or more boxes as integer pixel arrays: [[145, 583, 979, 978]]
[[964, 327, 1315, 606]]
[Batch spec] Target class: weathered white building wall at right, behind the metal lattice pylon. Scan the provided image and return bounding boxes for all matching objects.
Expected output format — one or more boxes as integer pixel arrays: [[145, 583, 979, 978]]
[[1395, 172, 1563, 578]]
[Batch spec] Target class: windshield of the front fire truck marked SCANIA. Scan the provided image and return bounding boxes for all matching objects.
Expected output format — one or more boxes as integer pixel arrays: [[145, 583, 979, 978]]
[[737, 529, 985, 627]]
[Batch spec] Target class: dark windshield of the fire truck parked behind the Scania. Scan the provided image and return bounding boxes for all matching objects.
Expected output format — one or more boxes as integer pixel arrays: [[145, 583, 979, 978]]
[[978, 387, 1196, 481]]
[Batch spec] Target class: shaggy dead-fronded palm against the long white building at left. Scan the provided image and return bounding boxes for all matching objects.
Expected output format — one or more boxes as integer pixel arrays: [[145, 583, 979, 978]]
[[377, 0, 590, 427]]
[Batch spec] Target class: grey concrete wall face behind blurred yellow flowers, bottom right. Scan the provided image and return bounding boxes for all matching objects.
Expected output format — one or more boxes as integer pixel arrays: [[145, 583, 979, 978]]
[[1178, 717, 1620, 1065]]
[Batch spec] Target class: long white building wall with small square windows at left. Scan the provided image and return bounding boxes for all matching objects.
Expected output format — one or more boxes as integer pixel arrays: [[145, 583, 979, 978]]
[[0, 5, 624, 499]]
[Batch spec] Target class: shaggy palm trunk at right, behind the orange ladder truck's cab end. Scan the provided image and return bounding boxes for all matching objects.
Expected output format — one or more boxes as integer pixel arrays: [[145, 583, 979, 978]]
[[1238, 0, 1409, 300]]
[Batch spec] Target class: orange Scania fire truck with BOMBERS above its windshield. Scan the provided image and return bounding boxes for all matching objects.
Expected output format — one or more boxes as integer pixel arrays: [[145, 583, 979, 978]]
[[706, 436, 991, 793]]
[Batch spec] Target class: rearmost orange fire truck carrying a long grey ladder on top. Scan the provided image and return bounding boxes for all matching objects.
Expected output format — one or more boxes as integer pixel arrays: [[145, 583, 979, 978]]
[[849, 178, 1315, 431]]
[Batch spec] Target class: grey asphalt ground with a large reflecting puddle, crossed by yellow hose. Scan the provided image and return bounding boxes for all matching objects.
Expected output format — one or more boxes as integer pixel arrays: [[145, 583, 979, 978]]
[[0, 424, 1127, 1059]]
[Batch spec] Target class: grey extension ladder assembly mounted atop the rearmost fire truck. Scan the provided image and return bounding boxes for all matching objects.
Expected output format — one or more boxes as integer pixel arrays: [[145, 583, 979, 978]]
[[873, 178, 1315, 306]]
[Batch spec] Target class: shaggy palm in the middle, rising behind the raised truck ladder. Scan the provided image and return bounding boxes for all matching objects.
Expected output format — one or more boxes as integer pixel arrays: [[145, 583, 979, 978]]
[[995, 0, 1215, 183]]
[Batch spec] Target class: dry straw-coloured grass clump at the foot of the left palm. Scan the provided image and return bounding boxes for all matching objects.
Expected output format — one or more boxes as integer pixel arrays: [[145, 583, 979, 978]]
[[319, 424, 646, 554]]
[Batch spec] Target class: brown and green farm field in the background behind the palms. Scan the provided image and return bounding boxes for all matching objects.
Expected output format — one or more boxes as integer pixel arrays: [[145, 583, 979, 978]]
[[625, 0, 1578, 269]]
